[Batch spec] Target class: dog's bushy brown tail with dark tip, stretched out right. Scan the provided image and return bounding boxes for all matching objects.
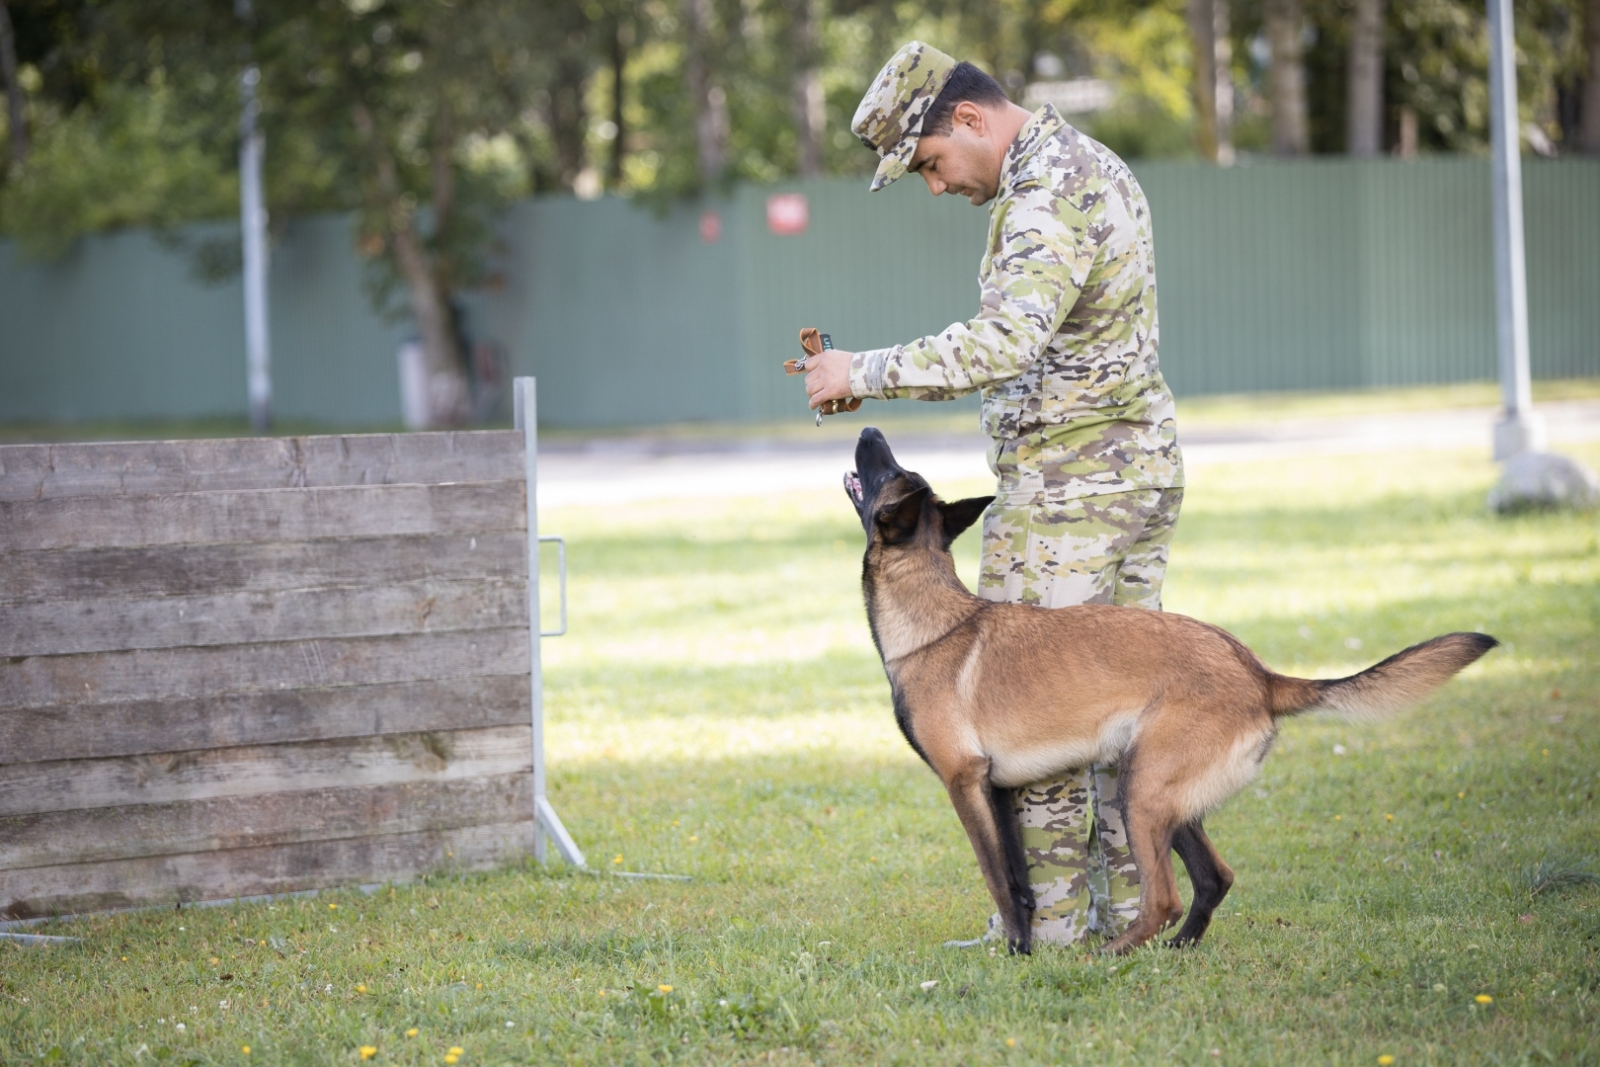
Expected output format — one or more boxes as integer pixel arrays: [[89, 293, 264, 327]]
[[1270, 633, 1499, 718]]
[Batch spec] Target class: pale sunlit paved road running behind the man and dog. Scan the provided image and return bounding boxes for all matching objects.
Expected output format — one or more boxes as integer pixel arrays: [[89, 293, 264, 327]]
[[539, 400, 1600, 507]]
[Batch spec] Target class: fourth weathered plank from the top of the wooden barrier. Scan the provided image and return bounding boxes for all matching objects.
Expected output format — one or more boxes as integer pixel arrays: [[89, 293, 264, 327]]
[[0, 581, 528, 656]]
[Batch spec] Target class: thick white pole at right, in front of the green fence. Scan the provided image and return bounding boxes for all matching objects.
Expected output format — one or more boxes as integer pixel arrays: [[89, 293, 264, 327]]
[[1488, 0, 1544, 459]]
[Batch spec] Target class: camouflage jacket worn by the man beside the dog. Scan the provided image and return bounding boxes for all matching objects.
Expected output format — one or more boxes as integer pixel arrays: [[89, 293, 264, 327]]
[[850, 106, 1184, 506]]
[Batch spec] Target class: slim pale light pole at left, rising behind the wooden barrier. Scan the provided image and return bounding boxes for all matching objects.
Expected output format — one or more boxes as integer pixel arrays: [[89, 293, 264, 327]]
[[234, 0, 272, 434]]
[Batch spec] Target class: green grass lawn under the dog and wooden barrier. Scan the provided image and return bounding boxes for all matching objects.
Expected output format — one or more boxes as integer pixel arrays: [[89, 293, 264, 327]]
[[0, 446, 1600, 1065]]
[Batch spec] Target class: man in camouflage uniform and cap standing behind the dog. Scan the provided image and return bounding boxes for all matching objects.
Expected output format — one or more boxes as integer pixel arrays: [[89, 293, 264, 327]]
[[806, 42, 1184, 944]]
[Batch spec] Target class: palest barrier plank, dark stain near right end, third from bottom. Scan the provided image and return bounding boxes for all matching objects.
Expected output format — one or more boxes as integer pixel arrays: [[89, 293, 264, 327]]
[[0, 726, 533, 816]]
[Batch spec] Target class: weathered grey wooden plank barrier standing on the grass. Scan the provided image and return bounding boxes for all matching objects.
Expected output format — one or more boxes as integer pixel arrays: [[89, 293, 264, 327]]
[[0, 425, 539, 920]]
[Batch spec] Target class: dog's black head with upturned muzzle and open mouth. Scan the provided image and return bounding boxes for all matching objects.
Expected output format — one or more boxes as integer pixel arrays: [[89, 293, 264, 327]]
[[845, 426, 995, 552]]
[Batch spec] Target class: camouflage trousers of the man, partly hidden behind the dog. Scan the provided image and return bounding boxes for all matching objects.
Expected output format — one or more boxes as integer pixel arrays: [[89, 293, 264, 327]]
[[978, 490, 1184, 944]]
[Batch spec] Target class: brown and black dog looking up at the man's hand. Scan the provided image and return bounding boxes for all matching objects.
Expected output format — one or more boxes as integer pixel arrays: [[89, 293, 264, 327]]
[[845, 427, 1498, 953]]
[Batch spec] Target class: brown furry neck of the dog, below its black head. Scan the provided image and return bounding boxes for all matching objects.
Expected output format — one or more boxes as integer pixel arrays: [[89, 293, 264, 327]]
[[861, 545, 984, 665]]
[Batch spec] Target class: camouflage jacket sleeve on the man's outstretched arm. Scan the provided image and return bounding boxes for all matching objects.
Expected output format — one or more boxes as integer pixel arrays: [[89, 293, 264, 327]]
[[850, 184, 1094, 400]]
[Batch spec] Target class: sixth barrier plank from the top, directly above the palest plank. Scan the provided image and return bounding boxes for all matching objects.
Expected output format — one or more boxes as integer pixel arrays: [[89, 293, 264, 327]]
[[0, 675, 528, 765]]
